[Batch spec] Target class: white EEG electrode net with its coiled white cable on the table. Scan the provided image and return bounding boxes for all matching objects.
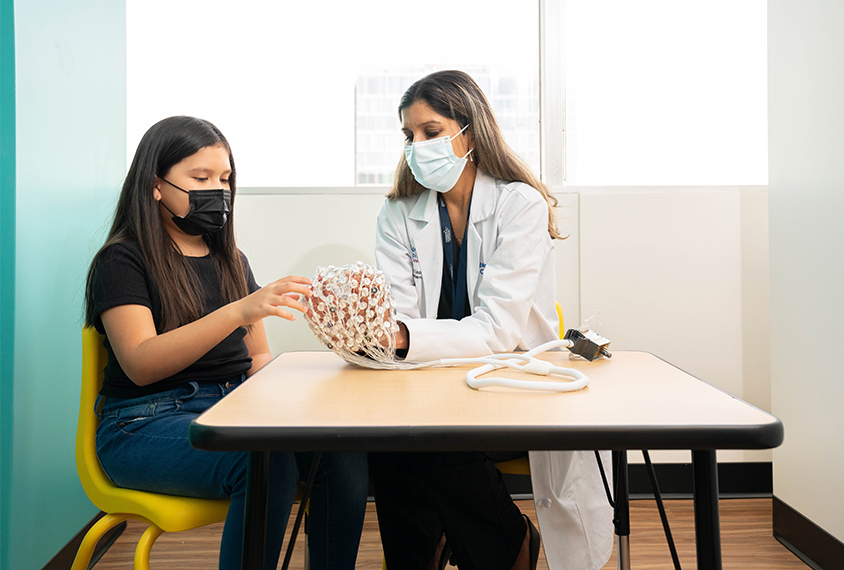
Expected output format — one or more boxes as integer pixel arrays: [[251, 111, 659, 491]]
[[303, 261, 589, 392]]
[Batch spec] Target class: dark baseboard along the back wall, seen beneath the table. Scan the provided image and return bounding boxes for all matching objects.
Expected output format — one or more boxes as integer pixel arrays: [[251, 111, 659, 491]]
[[504, 462, 773, 499]]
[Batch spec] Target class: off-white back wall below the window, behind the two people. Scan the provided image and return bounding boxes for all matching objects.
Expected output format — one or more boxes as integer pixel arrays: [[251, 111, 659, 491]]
[[236, 186, 771, 462]]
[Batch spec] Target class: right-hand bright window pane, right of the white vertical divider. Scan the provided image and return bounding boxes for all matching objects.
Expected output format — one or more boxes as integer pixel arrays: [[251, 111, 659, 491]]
[[565, 0, 768, 186]]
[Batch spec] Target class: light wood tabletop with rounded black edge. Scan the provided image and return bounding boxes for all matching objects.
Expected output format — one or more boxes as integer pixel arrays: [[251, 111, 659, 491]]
[[191, 351, 782, 451]]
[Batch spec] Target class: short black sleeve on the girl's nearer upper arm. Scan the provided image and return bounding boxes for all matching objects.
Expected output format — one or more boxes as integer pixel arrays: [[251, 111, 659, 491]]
[[92, 243, 154, 334]]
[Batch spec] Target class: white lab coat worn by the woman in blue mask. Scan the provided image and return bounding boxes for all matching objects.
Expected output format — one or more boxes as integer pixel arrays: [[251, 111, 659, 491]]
[[375, 171, 613, 570]]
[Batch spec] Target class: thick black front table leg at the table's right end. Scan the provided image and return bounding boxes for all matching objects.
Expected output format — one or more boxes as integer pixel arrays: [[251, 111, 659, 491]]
[[692, 450, 721, 570]]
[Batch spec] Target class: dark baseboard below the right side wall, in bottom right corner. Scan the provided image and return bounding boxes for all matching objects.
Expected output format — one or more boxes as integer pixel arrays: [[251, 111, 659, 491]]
[[773, 497, 844, 570]]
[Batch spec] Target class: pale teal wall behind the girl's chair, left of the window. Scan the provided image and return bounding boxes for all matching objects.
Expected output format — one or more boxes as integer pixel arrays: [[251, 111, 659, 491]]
[[3, 0, 126, 570]]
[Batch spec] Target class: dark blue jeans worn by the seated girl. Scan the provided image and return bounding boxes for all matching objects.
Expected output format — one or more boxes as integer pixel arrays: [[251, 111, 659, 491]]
[[97, 377, 369, 570]]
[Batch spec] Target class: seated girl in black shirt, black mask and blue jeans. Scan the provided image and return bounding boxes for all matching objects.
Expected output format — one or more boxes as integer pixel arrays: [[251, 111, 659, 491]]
[[85, 117, 367, 569]]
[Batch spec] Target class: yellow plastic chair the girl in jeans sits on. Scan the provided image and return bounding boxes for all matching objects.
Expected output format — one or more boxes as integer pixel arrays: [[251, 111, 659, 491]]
[[71, 327, 229, 570]]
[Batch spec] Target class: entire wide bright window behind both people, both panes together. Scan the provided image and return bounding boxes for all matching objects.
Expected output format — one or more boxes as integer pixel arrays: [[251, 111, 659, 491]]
[[127, 0, 767, 188]]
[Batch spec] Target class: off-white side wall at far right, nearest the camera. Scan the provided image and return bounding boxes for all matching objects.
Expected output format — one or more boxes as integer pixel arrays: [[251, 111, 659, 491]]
[[768, 0, 844, 540]]
